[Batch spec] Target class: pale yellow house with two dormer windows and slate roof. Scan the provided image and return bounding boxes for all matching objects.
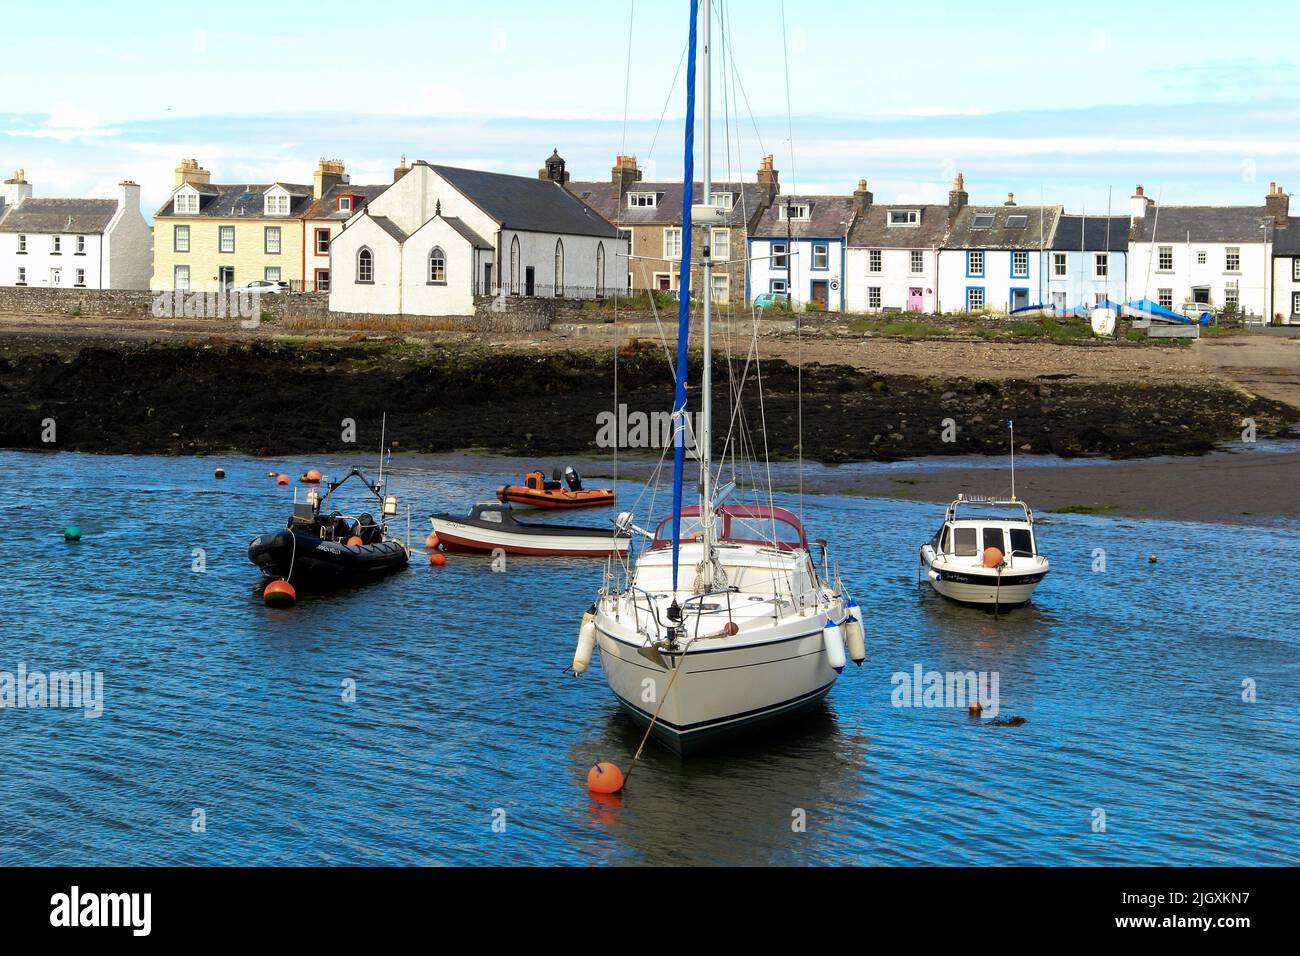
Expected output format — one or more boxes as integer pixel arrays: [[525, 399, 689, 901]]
[[150, 159, 312, 291]]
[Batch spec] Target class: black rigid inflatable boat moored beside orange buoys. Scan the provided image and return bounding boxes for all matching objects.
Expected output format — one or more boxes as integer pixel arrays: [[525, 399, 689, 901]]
[[248, 468, 411, 587]]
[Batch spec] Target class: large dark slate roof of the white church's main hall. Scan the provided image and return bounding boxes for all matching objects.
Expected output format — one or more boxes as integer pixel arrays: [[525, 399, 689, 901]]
[[426, 164, 619, 238]]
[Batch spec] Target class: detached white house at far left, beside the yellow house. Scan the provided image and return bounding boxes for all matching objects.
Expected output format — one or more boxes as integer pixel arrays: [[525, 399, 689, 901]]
[[0, 169, 153, 289]]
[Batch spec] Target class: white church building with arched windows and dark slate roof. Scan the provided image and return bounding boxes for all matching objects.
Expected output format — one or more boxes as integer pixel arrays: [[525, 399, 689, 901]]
[[329, 157, 628, 316]]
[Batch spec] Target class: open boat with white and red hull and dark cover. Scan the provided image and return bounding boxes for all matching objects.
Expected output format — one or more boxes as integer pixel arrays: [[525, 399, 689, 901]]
[[429, 502, 631, 557]]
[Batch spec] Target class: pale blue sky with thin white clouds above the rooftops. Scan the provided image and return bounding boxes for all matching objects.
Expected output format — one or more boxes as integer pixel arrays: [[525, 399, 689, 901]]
[[0, 0, 1300, 213]]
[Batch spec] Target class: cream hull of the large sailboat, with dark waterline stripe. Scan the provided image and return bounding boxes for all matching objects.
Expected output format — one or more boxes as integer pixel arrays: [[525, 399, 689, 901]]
[[597, 617, 839, 756]]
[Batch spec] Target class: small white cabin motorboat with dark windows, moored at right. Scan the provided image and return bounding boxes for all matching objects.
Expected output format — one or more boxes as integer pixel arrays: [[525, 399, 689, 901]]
[[920, 494, 1050, 607]]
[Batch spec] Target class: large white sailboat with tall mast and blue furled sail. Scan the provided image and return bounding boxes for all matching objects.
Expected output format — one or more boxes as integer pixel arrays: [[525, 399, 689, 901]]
[[573, 0, 866, 753]]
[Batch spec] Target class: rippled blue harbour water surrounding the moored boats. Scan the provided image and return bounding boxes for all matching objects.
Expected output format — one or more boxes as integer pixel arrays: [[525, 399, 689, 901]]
[[0, 453, 1300, 865]]
